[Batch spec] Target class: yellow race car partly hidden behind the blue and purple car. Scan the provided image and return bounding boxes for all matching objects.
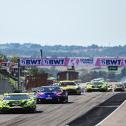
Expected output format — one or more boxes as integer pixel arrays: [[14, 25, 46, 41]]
[[59, 80, 81, 95]]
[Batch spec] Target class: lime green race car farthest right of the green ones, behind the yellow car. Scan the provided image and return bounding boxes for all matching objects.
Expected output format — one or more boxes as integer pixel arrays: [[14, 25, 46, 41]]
[[86, 78, 109, 92]]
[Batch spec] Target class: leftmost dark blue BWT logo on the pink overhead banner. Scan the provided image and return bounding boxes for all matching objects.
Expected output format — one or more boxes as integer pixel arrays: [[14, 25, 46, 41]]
[[20, 59, 42, 65]]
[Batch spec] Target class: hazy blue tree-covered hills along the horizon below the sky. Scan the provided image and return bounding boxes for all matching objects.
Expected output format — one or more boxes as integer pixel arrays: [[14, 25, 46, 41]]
[[0, 43, 126, 57]]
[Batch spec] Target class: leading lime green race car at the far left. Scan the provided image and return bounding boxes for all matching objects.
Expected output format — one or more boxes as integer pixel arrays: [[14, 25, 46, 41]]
[[0, 93, 36, 112]]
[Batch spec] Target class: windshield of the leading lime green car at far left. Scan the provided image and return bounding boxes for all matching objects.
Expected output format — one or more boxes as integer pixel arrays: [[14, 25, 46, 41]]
[[3, 95, 30, 100]]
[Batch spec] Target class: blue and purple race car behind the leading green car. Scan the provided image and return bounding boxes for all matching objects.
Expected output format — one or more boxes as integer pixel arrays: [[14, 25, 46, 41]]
[[36, 86, 68, 103]]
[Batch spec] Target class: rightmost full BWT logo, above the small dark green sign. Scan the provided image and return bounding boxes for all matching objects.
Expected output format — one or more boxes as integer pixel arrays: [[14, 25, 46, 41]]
[[100, 59, 122, 66]]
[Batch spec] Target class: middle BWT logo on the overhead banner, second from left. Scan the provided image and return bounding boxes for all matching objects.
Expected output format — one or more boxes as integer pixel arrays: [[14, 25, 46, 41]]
[[43, 59, 64, 65]]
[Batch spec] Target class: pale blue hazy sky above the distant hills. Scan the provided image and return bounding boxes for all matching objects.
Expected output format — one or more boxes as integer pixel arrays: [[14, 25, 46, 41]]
[[0, 0, 126, 46]]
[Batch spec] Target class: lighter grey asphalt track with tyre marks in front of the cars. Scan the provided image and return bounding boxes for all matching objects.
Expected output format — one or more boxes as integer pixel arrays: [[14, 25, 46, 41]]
[[0, 92, 114, 126]]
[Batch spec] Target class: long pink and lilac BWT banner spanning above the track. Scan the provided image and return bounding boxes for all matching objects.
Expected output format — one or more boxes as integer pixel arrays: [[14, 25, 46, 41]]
[[20, 57, 126, 67]]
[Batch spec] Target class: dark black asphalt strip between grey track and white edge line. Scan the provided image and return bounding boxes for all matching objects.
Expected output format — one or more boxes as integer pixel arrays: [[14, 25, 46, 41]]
[[69, 93, 126, 126]]
